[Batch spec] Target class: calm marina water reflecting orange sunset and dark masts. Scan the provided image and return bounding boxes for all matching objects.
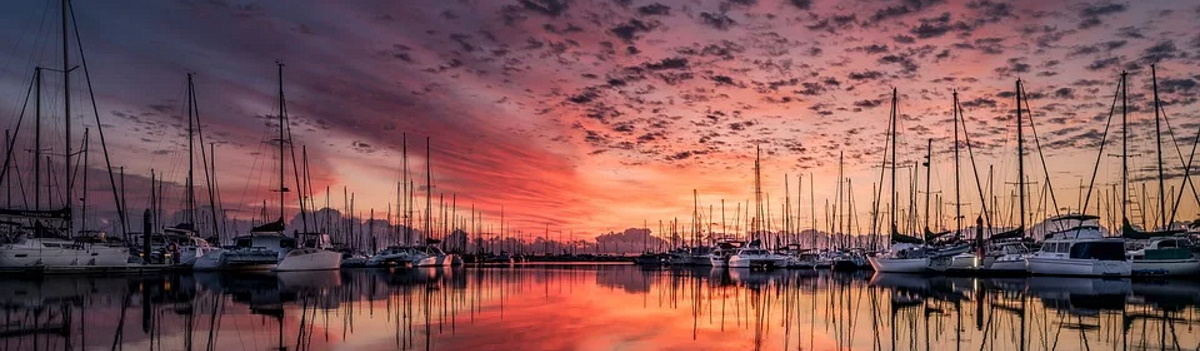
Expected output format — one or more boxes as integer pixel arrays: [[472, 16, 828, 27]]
[[0, 266, 1200, 351]]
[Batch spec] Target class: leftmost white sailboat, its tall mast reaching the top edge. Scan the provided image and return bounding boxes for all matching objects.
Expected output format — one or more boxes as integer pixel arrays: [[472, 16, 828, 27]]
[[0, 0, 130, 272]]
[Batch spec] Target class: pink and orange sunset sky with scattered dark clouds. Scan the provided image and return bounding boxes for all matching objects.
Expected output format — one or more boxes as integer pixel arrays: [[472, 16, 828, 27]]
[[0, 0, 1200, 237]]
